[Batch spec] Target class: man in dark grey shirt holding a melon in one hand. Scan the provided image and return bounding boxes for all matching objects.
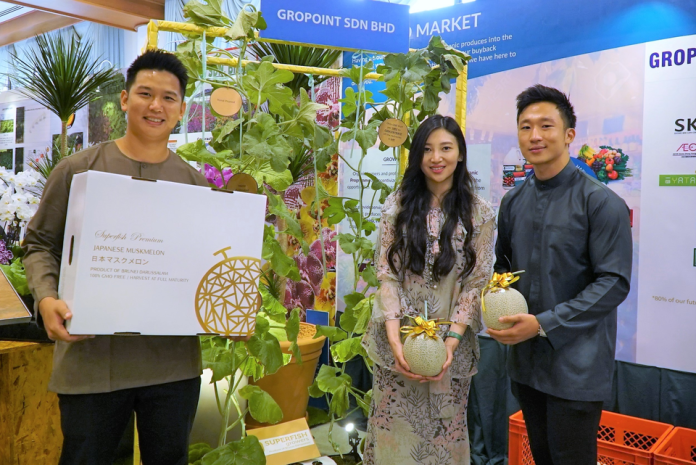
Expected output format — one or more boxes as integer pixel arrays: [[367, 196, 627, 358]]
[[488, 85, 633, 465]]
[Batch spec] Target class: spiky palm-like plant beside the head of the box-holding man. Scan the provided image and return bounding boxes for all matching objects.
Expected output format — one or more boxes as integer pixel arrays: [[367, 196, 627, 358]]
[[11, 33, 117, 155]]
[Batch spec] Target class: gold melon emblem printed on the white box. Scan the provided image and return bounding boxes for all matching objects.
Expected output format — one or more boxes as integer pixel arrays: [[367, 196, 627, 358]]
[[196, 247, 261, 336]]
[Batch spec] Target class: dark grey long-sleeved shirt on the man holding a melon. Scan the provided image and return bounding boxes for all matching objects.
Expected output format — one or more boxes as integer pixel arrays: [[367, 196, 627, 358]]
[[495, 159, 633, 401]]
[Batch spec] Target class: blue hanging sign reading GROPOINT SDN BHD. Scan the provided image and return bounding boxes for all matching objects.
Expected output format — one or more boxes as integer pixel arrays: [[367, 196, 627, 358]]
[[261, 0, 409, 53]]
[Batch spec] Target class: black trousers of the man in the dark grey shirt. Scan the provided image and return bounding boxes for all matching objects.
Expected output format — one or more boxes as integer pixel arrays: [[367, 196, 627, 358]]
[[512, 381, 603, 465]]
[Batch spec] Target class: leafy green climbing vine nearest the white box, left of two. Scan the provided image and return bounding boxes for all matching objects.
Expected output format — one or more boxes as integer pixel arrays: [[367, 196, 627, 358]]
[[176, 0, 332, 465]]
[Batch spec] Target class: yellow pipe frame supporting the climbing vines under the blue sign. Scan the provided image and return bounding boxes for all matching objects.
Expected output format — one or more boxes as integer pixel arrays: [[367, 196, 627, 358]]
[[145, 20, 469, 158]]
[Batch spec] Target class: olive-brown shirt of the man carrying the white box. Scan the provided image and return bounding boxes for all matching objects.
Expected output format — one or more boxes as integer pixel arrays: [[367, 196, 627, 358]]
[[23, 142, 208, 394]]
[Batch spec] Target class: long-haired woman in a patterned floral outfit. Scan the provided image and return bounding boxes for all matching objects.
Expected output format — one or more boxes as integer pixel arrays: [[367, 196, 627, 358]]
[[363, 115, 495, 465]]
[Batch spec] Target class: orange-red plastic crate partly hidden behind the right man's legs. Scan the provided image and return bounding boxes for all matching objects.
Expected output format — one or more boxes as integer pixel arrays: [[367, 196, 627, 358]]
[[508, 411, 672, 465]]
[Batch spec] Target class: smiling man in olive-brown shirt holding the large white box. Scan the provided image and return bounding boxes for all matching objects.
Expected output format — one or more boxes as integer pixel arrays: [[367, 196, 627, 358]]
[[24, 51, 208, 465]]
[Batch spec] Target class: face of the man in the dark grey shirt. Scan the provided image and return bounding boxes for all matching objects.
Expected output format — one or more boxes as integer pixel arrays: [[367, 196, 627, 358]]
[[517, 102, 575, 166]]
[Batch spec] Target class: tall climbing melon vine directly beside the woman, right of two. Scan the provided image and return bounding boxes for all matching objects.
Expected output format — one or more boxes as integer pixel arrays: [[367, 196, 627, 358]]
[[310, 37, 469, 450]]
